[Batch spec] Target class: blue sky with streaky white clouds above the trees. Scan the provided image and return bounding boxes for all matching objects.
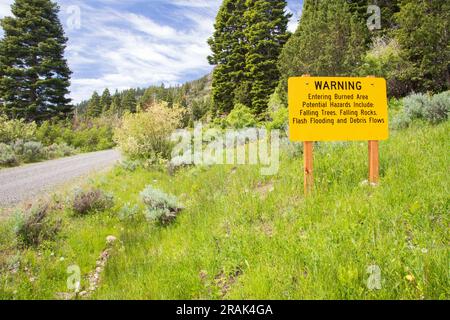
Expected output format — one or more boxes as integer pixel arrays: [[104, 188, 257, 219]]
[[0, 0, 302, 103]]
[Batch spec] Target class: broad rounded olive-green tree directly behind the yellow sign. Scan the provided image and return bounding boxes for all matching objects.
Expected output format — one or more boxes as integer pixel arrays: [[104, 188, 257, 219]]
[[279, 0, 369, 102]]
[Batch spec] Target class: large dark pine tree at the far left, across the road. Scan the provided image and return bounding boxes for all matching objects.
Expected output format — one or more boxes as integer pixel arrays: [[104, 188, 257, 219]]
[[0, 0, 73, 120]]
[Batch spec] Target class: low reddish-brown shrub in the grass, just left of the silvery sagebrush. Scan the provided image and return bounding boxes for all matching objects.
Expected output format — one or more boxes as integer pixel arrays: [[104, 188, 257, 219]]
[[72, 189, 114, 215]]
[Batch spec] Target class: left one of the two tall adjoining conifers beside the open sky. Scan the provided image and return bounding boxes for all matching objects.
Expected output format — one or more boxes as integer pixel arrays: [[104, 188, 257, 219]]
[[208, 0, 247, 114]]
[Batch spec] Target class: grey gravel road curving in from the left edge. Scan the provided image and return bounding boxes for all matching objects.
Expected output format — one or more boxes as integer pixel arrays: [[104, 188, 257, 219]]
[[0, 150, 121, 207]]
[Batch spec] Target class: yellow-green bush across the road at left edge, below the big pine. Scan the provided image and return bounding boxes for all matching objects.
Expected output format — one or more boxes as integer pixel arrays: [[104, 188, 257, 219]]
[[0, 115, 37, 143]]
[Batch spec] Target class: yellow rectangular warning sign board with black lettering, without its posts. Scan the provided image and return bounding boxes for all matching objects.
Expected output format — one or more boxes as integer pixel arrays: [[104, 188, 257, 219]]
[[289, 77, 389, 141]]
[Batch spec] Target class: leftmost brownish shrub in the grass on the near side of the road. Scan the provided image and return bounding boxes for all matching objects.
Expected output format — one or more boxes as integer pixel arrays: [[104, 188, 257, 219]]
[[15, 203, 61, 247]]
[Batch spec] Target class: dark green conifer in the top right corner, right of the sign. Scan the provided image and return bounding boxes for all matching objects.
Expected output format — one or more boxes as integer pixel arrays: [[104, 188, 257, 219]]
[[394, 0, 450, 92]]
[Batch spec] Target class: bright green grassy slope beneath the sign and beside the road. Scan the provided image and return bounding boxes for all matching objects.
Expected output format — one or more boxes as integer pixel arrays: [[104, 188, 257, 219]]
[[0, 122, 450, 299]]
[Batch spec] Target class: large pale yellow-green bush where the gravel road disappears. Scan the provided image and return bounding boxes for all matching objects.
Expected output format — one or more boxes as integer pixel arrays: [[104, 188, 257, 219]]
[[114, 104, 183, 162]]
